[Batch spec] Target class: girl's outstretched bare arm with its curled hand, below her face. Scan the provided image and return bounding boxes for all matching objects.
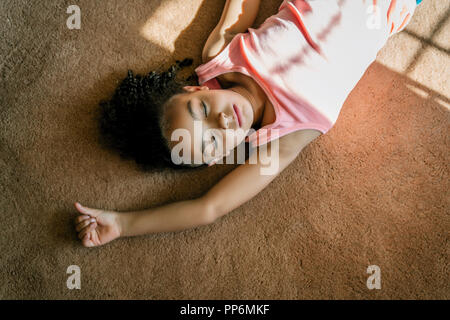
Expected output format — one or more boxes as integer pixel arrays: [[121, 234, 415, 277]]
[[76, 130, 320, 247]]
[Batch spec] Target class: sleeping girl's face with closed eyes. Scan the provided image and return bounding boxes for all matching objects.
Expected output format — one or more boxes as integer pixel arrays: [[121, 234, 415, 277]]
[[164, 86, 254, 165]]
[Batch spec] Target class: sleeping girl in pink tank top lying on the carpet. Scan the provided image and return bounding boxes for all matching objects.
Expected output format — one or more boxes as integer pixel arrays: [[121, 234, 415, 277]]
[[75, 0, 420, 247]]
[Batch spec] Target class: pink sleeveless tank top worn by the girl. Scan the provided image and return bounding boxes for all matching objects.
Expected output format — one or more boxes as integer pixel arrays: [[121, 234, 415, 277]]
[[195, 0, 416, 147]]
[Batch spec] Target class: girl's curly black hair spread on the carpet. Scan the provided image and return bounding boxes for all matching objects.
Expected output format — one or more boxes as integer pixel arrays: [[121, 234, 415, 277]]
[[98, 58, 198, 171]]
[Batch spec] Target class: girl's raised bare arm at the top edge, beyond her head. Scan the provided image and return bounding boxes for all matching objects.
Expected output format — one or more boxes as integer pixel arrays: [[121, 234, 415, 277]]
[[202, 0, 261, 63]]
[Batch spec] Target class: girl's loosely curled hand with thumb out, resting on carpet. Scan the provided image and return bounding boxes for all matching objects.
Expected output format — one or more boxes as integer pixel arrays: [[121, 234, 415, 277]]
[[75, 202, 121, 247]]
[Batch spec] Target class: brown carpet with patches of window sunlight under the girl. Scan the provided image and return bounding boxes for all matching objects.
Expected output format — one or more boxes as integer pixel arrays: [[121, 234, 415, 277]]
[[0, 0, 450, 299]]
